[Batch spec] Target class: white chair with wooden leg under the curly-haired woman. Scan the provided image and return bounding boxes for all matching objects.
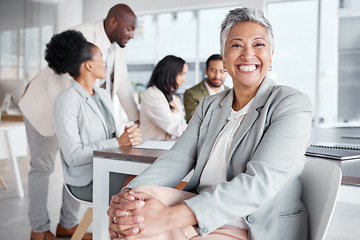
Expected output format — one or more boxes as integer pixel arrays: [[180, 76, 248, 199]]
[[64, 183, 93, 240]]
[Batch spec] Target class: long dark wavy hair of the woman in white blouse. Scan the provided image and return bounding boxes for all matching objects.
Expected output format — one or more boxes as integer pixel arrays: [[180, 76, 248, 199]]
[[147, 55, 186, 108]]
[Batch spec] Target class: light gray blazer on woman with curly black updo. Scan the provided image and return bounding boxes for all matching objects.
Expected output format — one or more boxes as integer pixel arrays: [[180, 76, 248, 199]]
[[53, 81, 120, 186]]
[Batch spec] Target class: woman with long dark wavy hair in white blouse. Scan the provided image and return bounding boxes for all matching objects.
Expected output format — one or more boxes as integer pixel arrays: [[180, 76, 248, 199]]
[[140, 55, 188, 140]]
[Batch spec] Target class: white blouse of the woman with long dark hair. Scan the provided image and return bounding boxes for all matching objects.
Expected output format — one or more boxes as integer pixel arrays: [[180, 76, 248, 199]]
[[140, 86, 187, 141]]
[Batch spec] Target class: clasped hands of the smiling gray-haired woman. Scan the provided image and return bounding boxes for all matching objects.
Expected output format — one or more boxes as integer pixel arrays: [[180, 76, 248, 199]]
[[107, 189, 172, 240]]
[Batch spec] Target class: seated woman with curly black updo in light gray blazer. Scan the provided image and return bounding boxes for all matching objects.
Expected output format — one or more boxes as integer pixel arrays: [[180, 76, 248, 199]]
[[45, 30, 141, 201]]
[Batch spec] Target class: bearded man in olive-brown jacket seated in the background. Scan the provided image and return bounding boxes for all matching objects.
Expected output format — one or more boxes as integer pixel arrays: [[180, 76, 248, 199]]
[[184, 54, 229, 123]]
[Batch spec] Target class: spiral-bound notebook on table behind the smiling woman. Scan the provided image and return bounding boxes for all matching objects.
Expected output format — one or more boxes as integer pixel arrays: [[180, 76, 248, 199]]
[[305, 143, 360, 161]]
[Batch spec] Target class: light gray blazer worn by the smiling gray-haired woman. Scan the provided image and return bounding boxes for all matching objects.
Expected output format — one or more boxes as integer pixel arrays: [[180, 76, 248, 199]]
[[128, 79, 312, 240]]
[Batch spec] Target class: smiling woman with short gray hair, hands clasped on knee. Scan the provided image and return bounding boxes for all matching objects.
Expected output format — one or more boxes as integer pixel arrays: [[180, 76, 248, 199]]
[[108, 8, 312, 240]]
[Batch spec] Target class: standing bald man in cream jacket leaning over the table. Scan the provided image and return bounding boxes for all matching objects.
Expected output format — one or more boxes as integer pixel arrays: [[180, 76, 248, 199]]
[[19, 4, 139, 240]]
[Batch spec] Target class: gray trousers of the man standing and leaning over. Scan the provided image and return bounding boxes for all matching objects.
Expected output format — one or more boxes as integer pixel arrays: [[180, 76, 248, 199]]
[[24, 117, 80, 232]]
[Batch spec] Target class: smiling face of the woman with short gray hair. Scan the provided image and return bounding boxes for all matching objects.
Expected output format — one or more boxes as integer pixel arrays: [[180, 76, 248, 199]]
[[223, 22, 272, 90]]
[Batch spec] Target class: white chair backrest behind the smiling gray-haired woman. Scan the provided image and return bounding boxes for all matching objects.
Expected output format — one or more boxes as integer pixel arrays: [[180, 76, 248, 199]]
[[301, 159, 342, 240]]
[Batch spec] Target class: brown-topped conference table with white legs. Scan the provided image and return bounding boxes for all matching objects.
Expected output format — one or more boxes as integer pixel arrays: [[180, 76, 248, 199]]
[[93, 128, 360, 239]]
